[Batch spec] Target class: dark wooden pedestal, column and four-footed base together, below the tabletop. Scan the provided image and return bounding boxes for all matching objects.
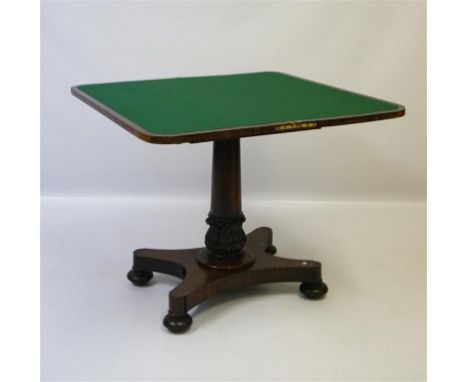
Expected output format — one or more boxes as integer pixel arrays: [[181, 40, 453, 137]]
[[128, 139, 328, 333]]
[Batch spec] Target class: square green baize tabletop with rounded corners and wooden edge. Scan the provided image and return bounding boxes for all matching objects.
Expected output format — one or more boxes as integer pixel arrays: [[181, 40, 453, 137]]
[[72, 72, 405, 143]]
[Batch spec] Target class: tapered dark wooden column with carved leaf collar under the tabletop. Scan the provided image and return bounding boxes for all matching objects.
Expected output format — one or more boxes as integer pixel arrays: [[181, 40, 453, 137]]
[[205, 139, 246, 261]]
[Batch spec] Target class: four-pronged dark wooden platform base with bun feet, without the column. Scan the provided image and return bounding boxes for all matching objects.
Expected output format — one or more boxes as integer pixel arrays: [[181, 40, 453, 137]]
[[128, 227, 328, 333]]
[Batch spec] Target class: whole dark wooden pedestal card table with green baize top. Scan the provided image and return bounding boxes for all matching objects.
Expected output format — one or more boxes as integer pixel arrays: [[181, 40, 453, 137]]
[[71, 72, 405, 333]]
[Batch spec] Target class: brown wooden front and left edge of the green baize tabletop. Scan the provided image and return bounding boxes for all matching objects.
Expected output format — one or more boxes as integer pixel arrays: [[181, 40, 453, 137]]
[[71, 85, 405, 144]]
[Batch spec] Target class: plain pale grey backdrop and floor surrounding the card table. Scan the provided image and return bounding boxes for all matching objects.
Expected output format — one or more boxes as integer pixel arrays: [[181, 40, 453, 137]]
[[41, 1, 426, 381]]
